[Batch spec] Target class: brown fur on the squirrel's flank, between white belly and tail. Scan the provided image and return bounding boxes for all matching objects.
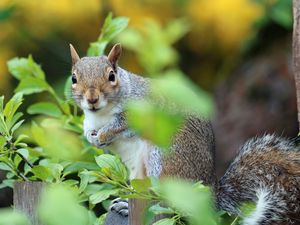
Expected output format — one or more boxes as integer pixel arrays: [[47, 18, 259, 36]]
[[162, 117, 216, 186]]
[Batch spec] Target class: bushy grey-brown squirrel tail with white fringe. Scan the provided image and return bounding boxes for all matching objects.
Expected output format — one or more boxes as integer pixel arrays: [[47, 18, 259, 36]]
[[217, 135, 300, 225]]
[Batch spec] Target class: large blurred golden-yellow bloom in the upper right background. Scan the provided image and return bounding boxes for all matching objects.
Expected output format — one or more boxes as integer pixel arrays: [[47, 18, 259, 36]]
[[189, 0, 263, 49]]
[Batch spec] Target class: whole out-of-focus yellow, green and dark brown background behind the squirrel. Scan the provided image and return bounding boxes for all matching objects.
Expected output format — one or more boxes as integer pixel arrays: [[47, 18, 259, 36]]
[[0, 0, 297, 176]]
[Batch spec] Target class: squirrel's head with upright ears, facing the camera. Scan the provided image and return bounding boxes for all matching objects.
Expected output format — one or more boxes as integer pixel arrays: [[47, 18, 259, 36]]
[[70, 44, 122, 112]]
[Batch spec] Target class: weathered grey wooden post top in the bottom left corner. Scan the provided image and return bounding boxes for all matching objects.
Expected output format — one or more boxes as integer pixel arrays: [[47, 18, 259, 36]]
[[14, 181, 44, 225]]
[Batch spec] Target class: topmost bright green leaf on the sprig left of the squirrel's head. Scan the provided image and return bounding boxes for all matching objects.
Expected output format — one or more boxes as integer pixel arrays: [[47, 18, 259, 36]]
[[7, 56, 45, 80]]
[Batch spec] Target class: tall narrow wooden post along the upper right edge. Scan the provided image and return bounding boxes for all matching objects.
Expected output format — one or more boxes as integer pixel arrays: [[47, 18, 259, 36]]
[[293, 0, 300, 130]]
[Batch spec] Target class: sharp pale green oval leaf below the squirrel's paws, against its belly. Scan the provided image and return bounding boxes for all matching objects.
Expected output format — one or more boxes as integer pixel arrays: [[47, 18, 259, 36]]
[[96, 154, 128, 182]]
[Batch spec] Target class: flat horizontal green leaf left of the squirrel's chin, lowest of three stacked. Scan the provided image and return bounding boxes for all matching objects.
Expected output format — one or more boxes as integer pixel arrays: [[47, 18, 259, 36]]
[[27, 102, 62, 118]]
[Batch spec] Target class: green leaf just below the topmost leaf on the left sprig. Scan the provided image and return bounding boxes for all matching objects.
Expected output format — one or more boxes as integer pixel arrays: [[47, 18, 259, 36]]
[[15, 77, 49, 95]]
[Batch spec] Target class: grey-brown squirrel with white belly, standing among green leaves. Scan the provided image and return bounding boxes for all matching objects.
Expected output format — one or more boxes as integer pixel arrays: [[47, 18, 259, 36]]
[[70, 44, 300, 225]]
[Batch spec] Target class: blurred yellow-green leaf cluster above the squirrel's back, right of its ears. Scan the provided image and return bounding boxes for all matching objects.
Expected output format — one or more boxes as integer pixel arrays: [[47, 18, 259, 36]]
[[118, 19, 189, 76]]
